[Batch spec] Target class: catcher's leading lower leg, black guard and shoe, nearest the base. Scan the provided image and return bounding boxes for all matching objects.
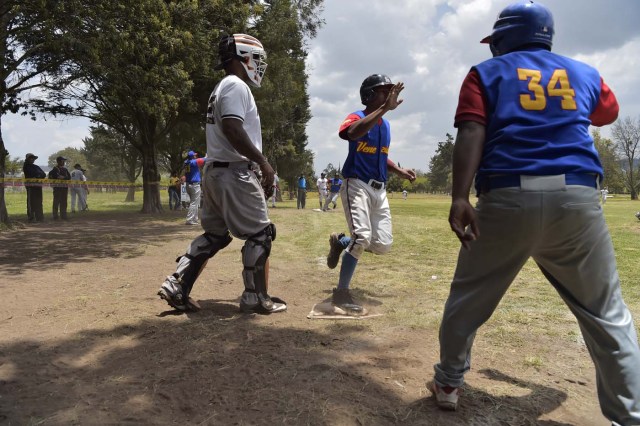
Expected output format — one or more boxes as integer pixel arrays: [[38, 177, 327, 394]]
[[240, 224, 286, 313]]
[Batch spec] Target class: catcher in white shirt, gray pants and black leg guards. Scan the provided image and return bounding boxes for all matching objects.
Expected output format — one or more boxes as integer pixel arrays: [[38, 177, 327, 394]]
[[158, 34, 287, 314]]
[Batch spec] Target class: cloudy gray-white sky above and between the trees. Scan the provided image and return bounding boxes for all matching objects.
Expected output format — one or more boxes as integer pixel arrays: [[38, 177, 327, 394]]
[[2, 0, 640, 175]]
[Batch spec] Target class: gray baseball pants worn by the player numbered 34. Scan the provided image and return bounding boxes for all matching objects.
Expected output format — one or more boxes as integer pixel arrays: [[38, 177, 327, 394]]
[[435, 185, 640, 425]]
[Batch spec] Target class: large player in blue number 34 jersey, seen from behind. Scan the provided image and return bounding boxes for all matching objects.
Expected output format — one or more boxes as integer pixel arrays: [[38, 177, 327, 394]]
[[432, 2, 640, 425]]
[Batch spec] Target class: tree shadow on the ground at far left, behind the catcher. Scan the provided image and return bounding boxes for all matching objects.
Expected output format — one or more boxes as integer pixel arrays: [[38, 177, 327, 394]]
[[0, 212, 185, 274]]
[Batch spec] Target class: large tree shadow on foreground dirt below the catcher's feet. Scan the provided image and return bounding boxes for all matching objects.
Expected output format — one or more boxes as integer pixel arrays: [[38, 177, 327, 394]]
[[0, 300, 567, 425]]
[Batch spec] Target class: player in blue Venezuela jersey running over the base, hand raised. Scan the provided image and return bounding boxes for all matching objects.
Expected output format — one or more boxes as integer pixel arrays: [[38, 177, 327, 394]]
[[327, 74, 416, 314]]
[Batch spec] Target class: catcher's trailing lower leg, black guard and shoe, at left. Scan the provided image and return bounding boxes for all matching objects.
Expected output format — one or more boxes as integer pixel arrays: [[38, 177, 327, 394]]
[[158, 232, 233, 310]]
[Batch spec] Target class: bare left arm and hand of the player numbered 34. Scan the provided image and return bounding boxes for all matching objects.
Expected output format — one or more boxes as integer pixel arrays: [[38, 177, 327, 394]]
[[449, 121, 485, 249]]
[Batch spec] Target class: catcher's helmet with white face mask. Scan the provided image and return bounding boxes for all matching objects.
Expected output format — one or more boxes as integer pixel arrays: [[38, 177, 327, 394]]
[[215, 34, 267, 87]]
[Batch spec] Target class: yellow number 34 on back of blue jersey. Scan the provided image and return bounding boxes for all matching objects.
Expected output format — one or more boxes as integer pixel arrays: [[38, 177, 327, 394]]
[[518, 68, 577, 111]]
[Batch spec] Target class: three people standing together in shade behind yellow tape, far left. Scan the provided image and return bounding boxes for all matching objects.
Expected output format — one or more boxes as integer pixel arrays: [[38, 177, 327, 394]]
[[22, 153, 89, 222]]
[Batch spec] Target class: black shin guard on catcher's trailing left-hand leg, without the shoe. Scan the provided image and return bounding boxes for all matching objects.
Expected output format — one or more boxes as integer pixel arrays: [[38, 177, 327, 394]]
[[173, 232, 233, 300]]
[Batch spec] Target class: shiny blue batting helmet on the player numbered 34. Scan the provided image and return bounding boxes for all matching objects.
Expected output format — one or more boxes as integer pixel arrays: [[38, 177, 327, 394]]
[[480, 1, 554, 56]]
